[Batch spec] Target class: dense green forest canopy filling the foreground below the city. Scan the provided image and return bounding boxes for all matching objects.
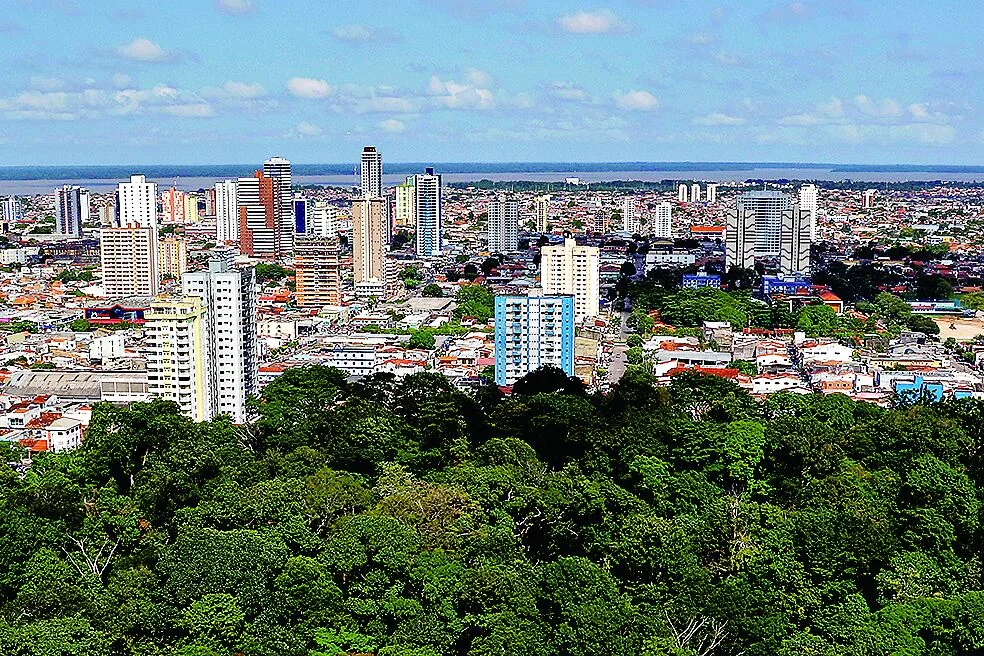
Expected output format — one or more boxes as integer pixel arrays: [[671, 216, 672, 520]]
[[0, 367, 984, 656]]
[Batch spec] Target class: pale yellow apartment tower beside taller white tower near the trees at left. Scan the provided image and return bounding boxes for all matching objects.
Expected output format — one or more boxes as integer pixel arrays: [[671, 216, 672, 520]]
[[144, 296, 215, 421]]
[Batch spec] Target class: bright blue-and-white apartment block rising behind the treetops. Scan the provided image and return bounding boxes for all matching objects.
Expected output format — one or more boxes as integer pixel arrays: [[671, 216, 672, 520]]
[[495, 293, 575, 386]]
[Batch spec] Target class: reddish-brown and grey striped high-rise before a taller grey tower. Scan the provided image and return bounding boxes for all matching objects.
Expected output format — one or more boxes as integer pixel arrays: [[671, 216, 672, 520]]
[[236, 171, 282, 258]]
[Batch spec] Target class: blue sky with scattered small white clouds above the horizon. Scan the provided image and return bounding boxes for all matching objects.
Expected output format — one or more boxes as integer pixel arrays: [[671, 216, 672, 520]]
[[0, 0, 984, 165]]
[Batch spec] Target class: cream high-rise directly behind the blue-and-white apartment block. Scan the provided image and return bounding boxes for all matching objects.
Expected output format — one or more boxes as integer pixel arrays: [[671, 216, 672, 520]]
[[540, 237, 599, 323]]
